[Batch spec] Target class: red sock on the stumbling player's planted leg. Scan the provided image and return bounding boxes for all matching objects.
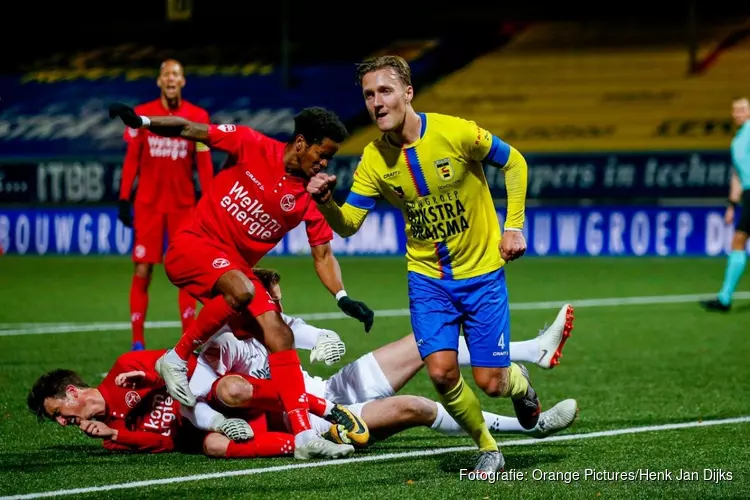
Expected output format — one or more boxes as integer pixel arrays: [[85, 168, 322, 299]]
[[268, 349, 312, 435]]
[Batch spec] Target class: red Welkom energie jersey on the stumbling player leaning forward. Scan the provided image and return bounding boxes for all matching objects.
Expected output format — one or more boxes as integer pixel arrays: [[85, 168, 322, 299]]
[[187, 125, 333, 266]]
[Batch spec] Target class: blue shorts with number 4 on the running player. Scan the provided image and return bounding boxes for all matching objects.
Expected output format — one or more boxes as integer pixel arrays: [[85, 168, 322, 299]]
[[409, 268, 510, 368]]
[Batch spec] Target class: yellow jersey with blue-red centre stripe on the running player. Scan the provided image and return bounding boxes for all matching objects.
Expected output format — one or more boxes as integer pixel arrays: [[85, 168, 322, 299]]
[[334, 113, 526, 279]]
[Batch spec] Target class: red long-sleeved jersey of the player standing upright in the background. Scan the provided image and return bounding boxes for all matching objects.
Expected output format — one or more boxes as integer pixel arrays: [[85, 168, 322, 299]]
[[120, 99, 213, 213]]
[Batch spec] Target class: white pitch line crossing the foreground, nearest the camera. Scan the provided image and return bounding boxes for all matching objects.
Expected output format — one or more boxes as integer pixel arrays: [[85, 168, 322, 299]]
[[5, 416, 750, 500]]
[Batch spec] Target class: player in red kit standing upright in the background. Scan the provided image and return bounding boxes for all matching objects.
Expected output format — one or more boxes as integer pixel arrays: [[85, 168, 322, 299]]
[[119, 59, 213, 350]]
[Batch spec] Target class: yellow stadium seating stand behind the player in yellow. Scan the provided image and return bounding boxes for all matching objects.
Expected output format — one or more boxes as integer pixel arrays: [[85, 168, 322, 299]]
[[344, 23, 750, 154]]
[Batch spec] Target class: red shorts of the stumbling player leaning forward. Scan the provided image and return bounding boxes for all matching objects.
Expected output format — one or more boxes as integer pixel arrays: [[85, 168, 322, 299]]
[[164, 230, 281, 317]]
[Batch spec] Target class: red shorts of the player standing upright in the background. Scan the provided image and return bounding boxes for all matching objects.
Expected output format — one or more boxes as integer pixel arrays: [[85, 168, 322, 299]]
[[133, 205, 193, 264]]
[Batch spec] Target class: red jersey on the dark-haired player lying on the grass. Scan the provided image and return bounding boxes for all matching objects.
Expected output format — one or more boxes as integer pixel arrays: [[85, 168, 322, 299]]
[[97, 350, 196, 453]]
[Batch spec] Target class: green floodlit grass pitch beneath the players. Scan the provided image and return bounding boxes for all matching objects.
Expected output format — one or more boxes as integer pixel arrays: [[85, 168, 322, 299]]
[[0, 256, 750, 499]]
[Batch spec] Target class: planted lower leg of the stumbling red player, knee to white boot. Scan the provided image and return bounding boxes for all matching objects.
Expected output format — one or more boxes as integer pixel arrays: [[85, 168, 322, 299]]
[[255, 311, 354, 460]]
